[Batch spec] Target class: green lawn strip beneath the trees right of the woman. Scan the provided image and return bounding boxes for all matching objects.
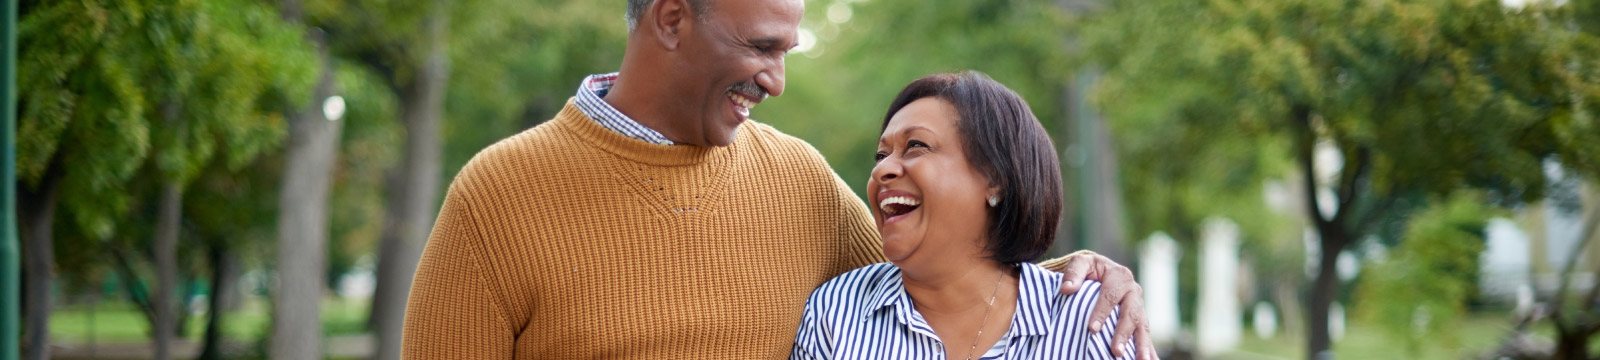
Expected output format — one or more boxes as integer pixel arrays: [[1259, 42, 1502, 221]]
[[1218, 314, 1555, 360]]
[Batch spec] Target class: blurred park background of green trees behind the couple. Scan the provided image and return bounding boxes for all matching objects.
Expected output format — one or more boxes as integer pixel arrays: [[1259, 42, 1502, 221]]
[[0, 0, 1600, 358]]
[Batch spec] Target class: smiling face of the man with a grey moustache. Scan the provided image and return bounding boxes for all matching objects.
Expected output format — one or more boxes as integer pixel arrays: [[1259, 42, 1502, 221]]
[[672, 0, 805, 146]]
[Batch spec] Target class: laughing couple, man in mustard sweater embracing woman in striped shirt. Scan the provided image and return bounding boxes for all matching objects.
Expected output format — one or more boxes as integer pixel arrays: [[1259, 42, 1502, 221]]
[[403, 0, 1154, 358]]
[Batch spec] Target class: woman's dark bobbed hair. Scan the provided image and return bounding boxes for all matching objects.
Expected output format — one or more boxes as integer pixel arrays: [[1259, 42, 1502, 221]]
[[878, 70, 1061, 264]]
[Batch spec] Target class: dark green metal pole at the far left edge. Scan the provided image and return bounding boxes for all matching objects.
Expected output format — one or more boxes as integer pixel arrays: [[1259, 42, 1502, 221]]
[[0, 0, 22, 353]]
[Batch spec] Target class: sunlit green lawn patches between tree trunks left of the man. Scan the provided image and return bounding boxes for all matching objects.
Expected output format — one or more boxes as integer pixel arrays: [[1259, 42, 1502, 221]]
[[50, 298, 370, 344]]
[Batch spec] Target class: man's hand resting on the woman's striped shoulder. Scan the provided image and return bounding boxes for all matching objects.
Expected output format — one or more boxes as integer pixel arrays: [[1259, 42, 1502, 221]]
[[1058, 250, 1157, 360]]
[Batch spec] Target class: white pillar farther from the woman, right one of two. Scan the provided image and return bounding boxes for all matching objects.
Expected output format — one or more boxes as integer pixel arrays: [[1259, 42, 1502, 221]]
[[1195, 218, 1243, 357]]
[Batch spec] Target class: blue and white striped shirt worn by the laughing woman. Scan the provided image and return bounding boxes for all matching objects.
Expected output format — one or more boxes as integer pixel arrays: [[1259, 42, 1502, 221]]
[[789, 262, 1134, 360]]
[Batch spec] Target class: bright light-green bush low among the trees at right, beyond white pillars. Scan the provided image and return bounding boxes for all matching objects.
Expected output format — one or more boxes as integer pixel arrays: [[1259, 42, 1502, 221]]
[[1355, 192, 1498, 355]]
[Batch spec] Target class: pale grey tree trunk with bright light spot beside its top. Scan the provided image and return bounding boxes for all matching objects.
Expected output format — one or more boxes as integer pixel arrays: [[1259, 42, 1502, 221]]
[[270, 30, 344, 360]]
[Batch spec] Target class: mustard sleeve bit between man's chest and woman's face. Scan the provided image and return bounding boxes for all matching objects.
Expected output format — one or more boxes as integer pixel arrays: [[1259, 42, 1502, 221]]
[[829, 174, 885, 278]]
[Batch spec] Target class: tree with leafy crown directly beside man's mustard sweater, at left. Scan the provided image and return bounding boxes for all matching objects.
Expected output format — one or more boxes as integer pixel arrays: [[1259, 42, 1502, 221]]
[[306, 0, 626, 358]]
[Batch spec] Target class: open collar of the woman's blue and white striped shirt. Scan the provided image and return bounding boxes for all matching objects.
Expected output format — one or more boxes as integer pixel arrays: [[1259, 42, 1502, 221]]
[[861, 264, 1061, 338]]
